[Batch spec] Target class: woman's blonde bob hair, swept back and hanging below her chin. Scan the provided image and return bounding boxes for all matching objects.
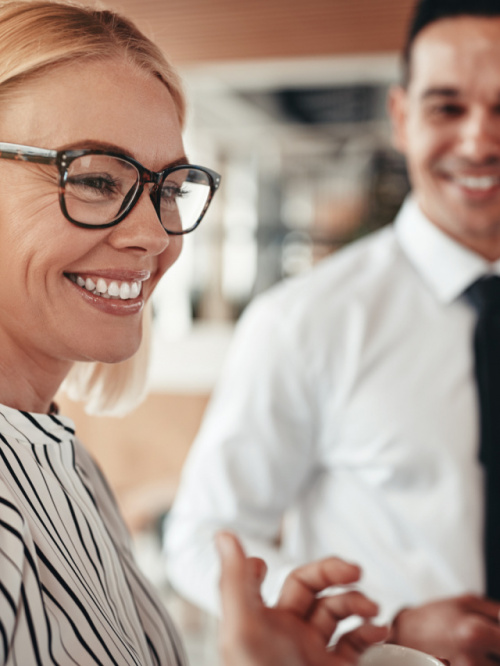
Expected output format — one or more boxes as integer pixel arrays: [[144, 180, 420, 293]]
[[0, 0, 185, 416]]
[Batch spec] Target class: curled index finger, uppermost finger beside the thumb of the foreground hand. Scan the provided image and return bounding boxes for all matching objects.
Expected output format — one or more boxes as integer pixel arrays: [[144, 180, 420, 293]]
[[277, 557, 361, 617]]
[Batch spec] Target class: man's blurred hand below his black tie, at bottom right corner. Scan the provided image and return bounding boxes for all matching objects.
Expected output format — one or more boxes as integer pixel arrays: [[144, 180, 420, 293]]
[[390, 595, 500, 666]]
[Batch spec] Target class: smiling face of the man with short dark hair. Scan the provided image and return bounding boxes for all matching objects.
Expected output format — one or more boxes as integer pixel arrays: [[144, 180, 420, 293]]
[[390, 16, 500, 260]]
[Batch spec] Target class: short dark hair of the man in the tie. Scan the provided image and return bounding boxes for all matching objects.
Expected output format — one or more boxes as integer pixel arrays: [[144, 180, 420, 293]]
[[403, 0, 500, 85]]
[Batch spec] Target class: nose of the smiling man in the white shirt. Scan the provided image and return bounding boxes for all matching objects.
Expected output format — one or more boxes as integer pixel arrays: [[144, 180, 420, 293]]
[[458, 108, 500, 163]]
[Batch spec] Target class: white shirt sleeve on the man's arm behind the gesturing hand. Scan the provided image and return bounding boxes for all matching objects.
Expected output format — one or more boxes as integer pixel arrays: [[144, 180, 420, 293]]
[[165, 297, 316, 612]]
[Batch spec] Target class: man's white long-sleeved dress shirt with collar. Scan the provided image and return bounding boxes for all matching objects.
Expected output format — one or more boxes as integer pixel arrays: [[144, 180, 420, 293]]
[[166, 199, 500, 621]]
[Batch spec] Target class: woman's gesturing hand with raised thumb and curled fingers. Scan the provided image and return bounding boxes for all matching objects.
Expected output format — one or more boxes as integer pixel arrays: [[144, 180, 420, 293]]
[[216, 532, 387, 666]]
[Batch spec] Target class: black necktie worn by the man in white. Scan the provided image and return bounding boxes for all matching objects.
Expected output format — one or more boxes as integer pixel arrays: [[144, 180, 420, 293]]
[[465, 276, 500, 600]]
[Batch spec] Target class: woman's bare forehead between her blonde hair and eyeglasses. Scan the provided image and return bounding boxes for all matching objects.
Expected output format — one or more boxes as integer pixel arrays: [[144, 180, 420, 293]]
[[0, 59, 182, 164]]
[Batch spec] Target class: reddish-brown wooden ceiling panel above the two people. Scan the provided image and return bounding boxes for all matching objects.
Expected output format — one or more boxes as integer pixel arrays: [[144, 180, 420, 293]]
[[106, 0, 414, 65]]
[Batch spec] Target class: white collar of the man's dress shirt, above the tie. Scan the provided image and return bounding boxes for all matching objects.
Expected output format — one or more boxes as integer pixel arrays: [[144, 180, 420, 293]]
[[395, 197, 500, 303]]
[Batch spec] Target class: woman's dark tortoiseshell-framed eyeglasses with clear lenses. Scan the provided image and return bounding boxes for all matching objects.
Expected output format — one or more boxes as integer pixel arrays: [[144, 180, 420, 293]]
[[0, 142, 221, 235]]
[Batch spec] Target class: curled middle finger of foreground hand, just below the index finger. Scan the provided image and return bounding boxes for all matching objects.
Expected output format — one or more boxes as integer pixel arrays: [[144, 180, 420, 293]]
[[309, 590, 378, 643]]
